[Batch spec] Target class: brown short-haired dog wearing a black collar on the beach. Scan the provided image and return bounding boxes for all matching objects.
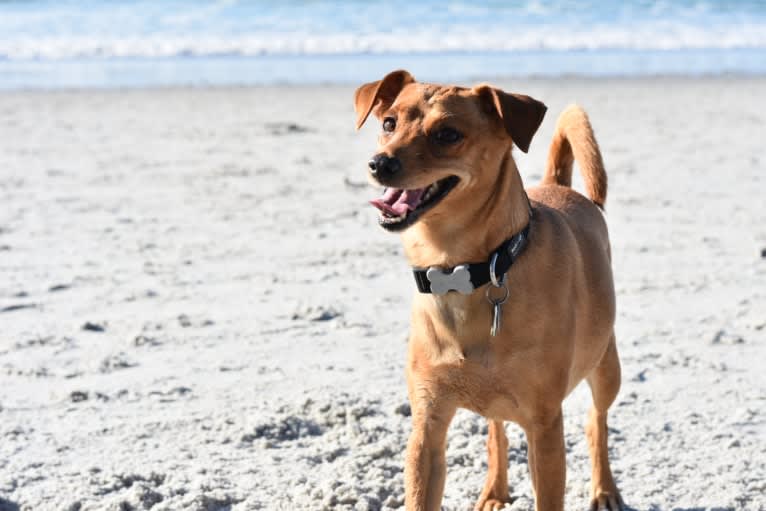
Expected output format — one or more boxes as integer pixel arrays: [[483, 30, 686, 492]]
[[355, 71, 623, 511]]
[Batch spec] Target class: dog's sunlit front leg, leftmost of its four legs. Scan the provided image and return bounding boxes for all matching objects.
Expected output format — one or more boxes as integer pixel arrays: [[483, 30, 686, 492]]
[[404, 389, 456, 511]]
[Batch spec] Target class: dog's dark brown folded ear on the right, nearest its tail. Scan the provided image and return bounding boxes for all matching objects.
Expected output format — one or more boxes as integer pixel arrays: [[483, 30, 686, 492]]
[[474, 85, 548, 153]]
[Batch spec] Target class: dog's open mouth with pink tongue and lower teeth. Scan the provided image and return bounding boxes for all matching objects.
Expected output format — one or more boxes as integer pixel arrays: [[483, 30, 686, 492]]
[[370, 176, 460, 231]]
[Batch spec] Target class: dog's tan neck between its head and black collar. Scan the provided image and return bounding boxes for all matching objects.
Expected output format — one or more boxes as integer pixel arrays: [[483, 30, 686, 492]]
[[402, 149, 529, 268]]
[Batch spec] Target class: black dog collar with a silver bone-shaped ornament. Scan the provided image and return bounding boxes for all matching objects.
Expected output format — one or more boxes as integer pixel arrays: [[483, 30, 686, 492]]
[[412, 224, 532, 295]]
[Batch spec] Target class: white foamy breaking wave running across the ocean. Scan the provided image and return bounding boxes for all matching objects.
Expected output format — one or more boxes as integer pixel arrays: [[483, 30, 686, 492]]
[[0, 25, 766, 60]]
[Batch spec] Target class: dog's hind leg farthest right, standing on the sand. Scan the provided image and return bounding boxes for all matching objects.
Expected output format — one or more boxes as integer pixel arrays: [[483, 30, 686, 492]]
[[585, 334, 624, 511]]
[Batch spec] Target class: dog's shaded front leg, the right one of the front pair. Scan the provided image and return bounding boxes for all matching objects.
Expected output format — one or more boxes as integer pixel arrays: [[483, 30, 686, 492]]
[[524, 408, 566, 511]]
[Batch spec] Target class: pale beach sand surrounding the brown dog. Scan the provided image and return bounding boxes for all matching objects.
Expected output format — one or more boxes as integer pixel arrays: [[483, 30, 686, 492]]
[[0, 78, 766, 511]]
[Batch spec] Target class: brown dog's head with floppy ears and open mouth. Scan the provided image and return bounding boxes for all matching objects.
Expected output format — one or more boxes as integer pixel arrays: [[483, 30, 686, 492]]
[[354, 71, 546, 231]]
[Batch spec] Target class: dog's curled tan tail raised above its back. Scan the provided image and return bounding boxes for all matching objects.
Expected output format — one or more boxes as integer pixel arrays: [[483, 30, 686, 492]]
[[542, 105, 606, 209]]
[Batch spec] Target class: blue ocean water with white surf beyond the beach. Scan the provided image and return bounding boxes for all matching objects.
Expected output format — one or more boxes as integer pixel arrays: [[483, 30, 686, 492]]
[[0, 0, 766, 89]]
